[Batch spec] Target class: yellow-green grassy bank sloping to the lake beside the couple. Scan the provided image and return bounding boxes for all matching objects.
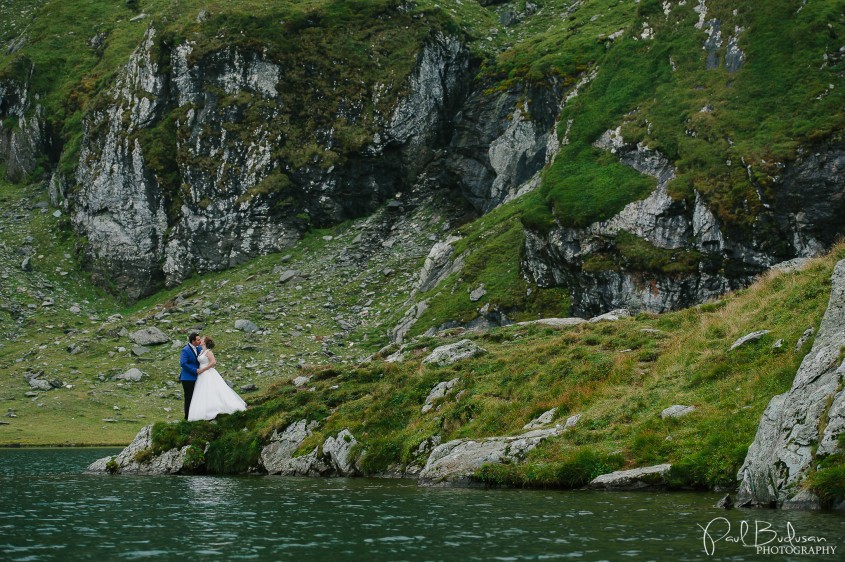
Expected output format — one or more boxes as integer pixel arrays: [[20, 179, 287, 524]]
[[143, 242, 845, 488]]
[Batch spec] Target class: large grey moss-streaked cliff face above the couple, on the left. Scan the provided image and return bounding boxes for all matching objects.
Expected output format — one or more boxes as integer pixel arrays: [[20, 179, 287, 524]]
[[64, 27, 470, 298]]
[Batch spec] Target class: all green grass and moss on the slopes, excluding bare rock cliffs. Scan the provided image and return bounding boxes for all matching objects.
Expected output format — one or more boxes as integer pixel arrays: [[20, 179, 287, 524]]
[[0, 0, 845, 502]]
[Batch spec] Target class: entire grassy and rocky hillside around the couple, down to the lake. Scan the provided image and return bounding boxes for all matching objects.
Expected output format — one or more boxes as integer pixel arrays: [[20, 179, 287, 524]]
[[0, 0, 845, 497]]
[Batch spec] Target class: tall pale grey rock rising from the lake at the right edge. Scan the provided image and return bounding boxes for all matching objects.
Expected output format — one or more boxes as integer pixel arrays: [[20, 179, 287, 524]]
[[737, 260, 845, 506]]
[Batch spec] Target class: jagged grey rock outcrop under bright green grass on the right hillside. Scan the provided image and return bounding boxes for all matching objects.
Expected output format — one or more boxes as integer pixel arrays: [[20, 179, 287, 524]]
[[522, 123, 845, 317]]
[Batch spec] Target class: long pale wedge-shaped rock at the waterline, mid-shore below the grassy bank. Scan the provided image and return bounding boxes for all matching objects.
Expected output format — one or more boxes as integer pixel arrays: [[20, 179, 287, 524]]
[[419, 427, 563, 486]]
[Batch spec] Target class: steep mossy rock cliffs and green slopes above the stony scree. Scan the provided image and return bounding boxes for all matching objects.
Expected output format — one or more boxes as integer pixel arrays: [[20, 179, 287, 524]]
[[0, 0, 845, 324]]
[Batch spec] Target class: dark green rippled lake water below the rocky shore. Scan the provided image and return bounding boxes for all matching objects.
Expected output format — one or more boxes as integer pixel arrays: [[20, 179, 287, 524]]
[[0, 449, 845, 561]]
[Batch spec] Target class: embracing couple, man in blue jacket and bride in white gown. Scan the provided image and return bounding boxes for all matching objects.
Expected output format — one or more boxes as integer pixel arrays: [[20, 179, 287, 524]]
[[179, 333, 246, 421]]
